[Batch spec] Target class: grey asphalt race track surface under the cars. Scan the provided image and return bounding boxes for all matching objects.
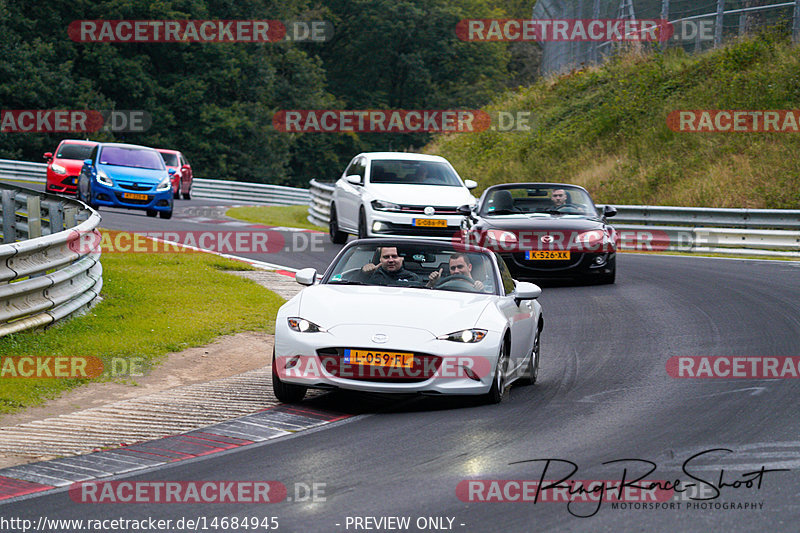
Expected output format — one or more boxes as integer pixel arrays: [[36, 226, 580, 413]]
[[0, 200, 800, 532]]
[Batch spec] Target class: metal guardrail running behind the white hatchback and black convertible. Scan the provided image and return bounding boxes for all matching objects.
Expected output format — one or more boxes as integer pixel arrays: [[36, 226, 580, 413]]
[[308, 180, 800, 257]]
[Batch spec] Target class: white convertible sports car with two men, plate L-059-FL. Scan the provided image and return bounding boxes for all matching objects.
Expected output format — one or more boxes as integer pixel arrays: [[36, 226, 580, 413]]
[[272, 239, 544, 403]]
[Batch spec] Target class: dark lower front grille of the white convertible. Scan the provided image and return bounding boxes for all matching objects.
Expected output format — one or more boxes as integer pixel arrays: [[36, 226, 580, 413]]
[[317, 348, 442, 383]]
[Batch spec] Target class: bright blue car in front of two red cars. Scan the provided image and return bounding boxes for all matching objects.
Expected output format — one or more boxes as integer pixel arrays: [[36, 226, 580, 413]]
[[78, 143, 175, 218]]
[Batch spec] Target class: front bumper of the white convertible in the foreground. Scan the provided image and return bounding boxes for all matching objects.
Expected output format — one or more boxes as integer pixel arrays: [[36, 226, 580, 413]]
[[275, 317, 502, 394]]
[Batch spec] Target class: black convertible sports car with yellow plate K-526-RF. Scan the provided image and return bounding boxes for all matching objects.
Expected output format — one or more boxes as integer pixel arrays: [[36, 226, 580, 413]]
[[459, 183, 617, 283]]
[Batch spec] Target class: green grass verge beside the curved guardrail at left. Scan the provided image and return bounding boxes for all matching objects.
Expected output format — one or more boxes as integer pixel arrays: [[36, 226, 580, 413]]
[[0, 245, 283, 413]]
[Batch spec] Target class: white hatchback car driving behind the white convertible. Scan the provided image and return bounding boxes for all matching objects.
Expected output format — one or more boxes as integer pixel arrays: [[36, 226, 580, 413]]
[[329, 152, 478, 244]]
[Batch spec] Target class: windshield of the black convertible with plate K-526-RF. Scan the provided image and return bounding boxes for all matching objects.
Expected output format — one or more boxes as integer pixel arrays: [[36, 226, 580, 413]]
[[480, 184, 597, 216]]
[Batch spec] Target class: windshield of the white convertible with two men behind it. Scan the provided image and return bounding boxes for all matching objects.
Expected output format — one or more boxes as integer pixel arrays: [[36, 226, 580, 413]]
[[323, 242, 495, 294]]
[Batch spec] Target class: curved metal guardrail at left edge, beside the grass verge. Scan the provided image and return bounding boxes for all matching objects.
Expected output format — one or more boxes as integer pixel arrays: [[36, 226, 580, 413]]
[[0, 184, 103, 337]]
